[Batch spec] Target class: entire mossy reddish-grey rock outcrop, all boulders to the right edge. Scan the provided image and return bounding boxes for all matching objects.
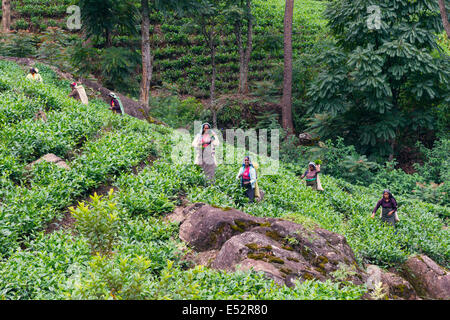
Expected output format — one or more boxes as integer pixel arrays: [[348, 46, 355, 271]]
[[168, 203, 450, 300]]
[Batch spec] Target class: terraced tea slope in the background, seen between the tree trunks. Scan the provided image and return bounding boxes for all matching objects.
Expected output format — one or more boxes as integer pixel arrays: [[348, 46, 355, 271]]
[[0, 0, 326, 98]]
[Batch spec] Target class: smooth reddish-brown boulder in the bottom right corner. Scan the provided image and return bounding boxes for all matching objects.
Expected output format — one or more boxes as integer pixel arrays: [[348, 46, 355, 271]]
[[402, 254, 450, 300]]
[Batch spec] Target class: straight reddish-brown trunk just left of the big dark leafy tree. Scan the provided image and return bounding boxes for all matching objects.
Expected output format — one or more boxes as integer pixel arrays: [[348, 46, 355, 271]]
[[281, 0, 294, 135]]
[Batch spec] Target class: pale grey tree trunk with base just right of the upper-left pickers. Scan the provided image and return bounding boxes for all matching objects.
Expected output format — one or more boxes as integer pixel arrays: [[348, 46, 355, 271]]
[[139, 0, 153, 105]]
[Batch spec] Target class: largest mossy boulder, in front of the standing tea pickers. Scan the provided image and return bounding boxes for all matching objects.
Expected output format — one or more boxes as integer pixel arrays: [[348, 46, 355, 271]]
[[174, 204, 366, 286]]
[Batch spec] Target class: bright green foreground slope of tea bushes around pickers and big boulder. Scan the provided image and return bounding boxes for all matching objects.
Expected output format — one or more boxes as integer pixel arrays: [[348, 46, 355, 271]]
[[0, 61, 450, 299]]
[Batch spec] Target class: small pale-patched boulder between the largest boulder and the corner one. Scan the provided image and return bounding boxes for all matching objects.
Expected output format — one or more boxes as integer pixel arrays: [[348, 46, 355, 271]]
[[366, 265, 419, 300]]
